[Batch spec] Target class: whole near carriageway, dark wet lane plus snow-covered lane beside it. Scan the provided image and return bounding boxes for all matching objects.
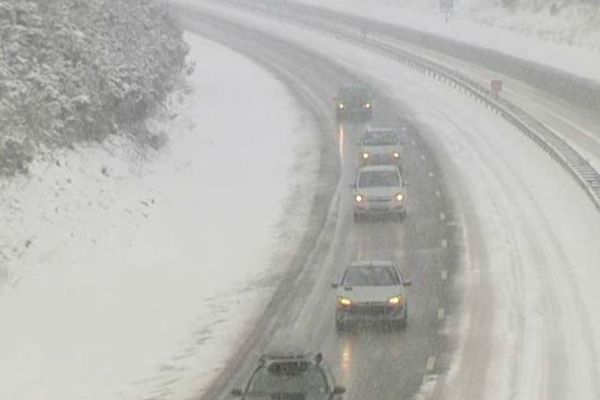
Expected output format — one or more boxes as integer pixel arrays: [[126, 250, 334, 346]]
[[169, 3, 600, 399]]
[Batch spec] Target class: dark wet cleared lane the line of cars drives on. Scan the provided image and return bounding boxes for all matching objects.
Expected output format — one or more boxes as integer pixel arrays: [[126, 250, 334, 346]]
[[172, 10, 459, 399]]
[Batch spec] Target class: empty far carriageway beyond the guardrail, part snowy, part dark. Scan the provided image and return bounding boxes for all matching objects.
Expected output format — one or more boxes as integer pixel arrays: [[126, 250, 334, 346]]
[[234, 0, 600, 169]]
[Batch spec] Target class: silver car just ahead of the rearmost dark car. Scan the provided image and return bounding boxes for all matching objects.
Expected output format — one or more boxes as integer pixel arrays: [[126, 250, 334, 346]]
[[358, 129, 402, 169]]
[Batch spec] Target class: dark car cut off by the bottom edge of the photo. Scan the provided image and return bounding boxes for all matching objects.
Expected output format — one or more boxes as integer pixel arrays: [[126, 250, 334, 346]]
[[231, 353, 346, 400]]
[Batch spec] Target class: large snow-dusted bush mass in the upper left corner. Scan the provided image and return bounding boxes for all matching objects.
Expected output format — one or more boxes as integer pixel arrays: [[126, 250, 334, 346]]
[[0, 0, 188, 175]]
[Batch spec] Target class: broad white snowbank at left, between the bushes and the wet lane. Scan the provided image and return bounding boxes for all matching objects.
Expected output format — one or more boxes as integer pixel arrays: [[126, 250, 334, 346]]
[[0, 35, 318, 400]]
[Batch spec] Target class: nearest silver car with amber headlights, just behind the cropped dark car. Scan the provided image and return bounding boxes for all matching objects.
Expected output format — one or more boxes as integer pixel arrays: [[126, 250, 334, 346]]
[[332, 261, 411, 329]]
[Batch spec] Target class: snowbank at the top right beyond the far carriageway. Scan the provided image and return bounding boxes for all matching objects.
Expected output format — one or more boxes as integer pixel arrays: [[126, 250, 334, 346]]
[[294, 0, 600, 82]]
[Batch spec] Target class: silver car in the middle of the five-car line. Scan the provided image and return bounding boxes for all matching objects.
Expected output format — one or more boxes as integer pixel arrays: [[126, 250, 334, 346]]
[[353, 165, 406, 222]]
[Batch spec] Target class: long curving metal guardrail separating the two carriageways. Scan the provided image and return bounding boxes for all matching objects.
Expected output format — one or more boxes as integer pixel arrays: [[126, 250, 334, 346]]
[[207, 0, 600, 211]]
